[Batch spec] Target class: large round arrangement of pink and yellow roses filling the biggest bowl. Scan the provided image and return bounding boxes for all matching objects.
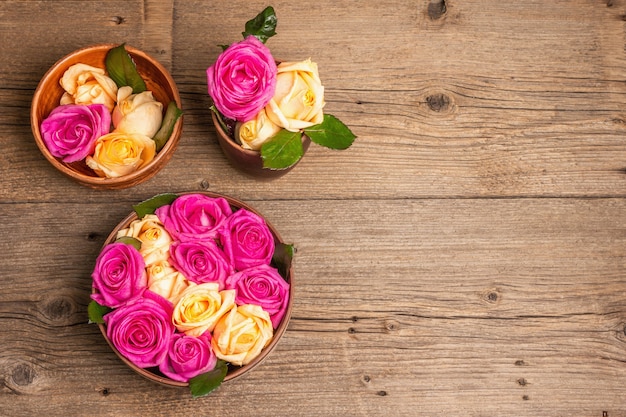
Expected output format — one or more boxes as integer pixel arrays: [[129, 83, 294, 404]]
[[88, 193, 293, 396]]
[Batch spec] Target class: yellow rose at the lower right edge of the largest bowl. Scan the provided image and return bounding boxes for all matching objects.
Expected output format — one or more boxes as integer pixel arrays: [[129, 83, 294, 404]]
[[211, 304, 274, 366]]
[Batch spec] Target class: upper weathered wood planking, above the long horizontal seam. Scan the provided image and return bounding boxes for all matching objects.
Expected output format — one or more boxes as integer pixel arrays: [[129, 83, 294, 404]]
[[0, 1, 626, 201]]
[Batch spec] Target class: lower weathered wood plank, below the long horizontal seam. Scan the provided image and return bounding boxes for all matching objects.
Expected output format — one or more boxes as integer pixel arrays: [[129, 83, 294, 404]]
[[0, 199, 626, 416]]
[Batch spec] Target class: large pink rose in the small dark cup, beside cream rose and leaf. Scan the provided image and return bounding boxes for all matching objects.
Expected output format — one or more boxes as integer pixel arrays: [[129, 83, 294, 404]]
[[207, 36, 278, 122]]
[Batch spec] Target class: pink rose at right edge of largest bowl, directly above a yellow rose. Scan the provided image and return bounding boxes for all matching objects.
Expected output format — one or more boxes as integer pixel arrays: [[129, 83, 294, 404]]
[[226, 265, 289, 328]]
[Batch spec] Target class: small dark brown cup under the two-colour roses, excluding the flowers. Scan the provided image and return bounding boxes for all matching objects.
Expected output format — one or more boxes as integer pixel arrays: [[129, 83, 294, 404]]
[[211, 111, 311, 180]]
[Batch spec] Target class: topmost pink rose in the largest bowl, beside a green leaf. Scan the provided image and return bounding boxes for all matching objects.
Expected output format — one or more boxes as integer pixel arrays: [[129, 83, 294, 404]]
[[155, 194, 232, 242]]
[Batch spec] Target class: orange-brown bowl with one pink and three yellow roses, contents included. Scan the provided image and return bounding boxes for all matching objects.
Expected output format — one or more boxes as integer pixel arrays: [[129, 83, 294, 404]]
[[31, 44, 182, 188]]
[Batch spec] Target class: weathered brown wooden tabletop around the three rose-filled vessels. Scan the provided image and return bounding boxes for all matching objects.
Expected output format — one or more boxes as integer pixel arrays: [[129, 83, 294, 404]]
[[0, 0, 626, 417]]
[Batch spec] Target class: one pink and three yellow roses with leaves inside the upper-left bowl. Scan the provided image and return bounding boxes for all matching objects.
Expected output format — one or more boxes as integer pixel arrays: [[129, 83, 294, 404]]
[[40, 44, 182, 178]]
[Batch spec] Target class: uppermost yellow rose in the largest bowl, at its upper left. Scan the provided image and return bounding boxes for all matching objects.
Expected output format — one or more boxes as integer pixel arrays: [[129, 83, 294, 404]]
[[117, 214, 172, 265]]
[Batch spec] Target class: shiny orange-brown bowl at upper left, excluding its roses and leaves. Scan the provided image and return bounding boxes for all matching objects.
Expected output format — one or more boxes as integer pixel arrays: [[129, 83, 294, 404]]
[[30, 44, 183, 189]]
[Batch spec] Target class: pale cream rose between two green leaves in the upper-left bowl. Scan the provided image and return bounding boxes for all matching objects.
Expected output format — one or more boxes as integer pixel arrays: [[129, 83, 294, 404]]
[[112, 86, 163, 137]]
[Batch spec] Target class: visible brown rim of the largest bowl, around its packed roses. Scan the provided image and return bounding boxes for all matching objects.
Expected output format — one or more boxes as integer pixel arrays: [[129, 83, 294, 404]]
[[92, 191, 294, 387]]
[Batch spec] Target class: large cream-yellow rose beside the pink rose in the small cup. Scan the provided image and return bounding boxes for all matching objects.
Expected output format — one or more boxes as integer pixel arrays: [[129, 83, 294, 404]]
[[265, 59, 326, 132]]
